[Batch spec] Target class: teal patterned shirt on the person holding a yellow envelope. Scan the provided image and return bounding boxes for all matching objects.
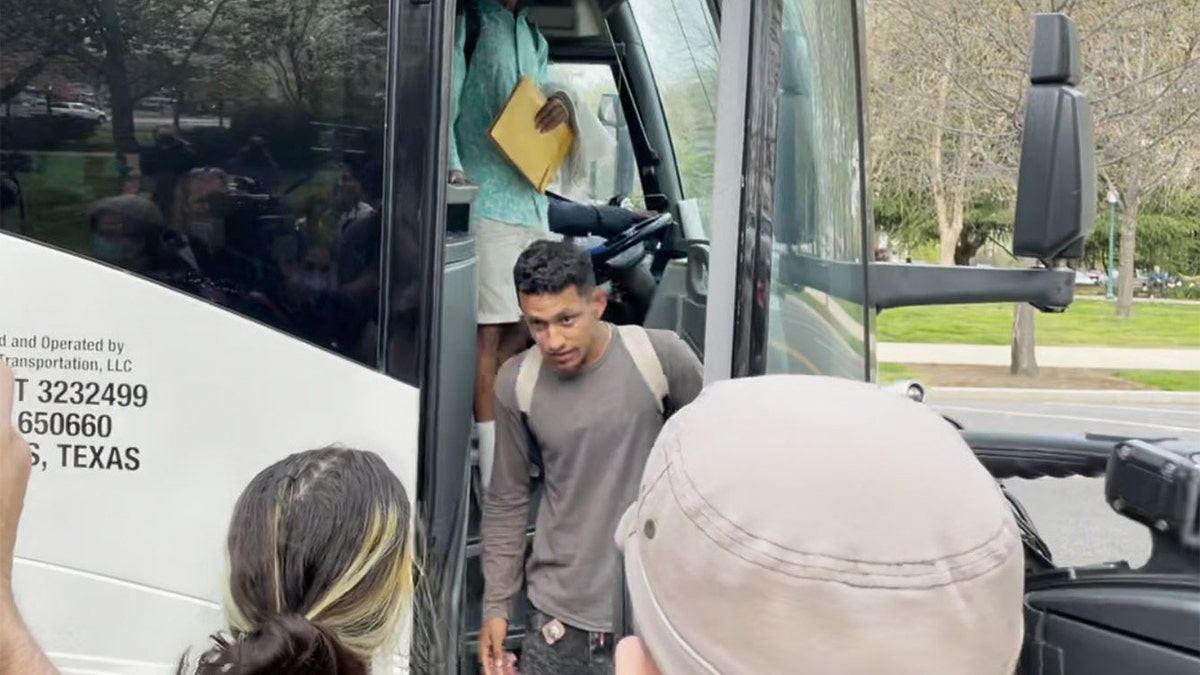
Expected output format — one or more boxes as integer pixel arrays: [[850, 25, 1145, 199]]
[[449, 0, 550, 231]]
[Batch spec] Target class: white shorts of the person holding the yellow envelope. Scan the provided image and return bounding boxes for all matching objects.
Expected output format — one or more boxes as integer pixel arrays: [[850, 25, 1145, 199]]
[[475, 217, 560, 325]]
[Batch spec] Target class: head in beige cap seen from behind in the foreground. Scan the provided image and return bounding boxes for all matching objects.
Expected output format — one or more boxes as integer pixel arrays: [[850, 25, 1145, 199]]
[[617, 376, 1025, 675]]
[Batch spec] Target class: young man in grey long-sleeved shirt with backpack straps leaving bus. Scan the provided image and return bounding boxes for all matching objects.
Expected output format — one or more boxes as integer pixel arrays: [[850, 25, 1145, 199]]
[[480, 241, 703, 675]]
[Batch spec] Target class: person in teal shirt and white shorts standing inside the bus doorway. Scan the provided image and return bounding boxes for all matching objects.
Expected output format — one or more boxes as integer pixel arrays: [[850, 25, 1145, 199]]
[[449, 0, 606, 486]]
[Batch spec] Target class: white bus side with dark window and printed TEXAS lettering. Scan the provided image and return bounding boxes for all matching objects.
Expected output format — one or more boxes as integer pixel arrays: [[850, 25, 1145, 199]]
[[0, 0, 465, 673]]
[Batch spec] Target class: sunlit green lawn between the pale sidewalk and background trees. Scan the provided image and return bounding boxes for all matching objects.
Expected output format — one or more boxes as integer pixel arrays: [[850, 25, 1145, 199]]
[[876, 301, 1200, 348]]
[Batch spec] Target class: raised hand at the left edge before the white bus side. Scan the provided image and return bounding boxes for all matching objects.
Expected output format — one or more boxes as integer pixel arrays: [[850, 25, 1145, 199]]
[[0, 359, 32, 586]]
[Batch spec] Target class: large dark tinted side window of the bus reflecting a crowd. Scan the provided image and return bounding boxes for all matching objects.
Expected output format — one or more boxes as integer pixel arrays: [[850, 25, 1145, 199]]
[[0, 0, 403, 365]]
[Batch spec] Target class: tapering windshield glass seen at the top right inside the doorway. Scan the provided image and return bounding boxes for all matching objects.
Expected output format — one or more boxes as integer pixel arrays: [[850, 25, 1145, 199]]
[[629, 0, 720, 234]]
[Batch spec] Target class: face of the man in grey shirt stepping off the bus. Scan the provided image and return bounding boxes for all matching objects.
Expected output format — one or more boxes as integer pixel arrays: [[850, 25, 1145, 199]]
[[520, 286, 608, 375]]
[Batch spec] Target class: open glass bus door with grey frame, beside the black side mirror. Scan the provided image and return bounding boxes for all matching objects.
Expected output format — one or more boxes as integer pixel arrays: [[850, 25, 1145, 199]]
[[706, 0, 872, 380]]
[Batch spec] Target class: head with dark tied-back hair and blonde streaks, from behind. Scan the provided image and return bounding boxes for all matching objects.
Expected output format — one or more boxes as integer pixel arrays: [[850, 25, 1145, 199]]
[[187, 447, 413, 675]]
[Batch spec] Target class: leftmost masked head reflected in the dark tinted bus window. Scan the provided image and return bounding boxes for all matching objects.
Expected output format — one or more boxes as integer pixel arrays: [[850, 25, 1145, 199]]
[[88, 195, 164, 270]]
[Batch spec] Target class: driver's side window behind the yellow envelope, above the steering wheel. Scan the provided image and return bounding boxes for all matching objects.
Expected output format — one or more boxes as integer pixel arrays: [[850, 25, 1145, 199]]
[[550, 61, 646, 209]]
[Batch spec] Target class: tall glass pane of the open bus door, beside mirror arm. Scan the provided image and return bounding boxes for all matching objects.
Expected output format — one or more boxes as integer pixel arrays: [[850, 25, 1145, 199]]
[[766, 0, 866, 380]]
